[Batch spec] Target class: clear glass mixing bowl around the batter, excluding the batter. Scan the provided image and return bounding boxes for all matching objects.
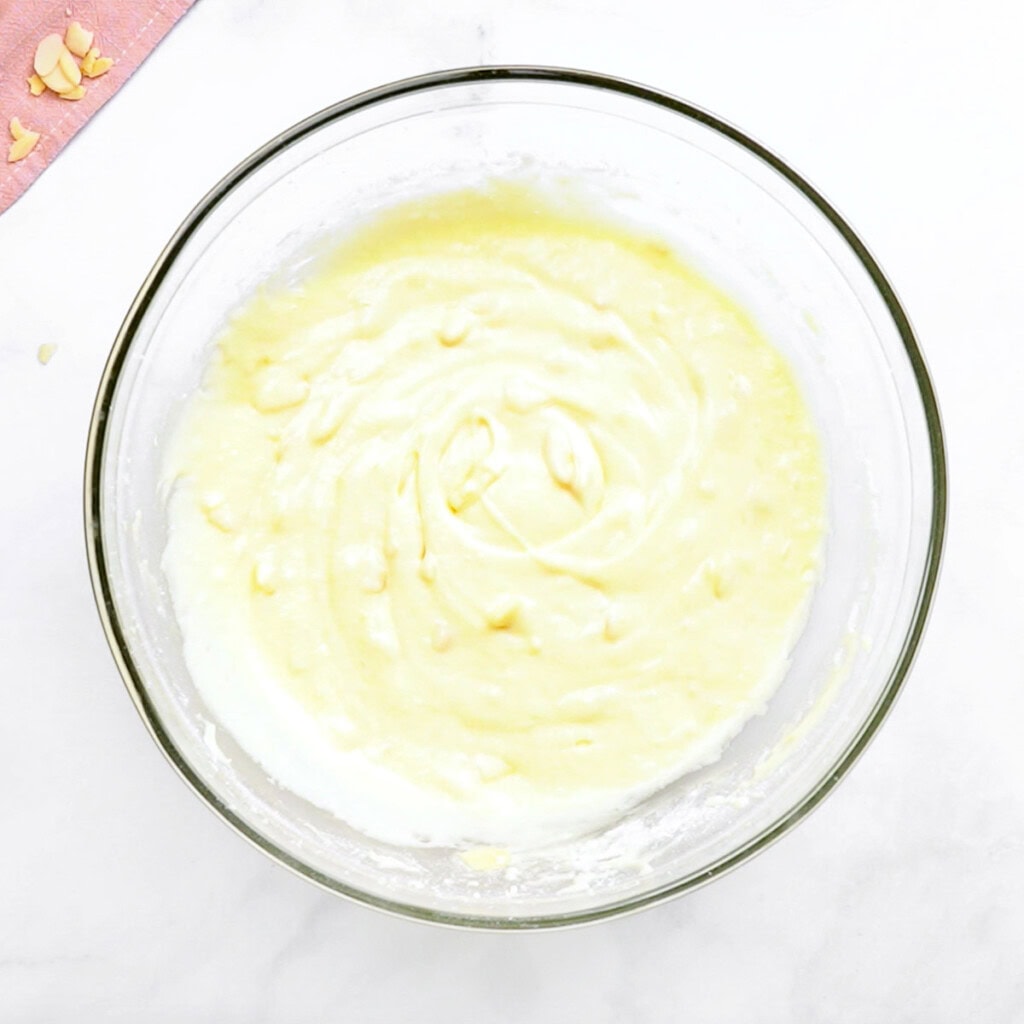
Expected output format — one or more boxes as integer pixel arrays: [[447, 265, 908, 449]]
[[85, 68, 946, 928]]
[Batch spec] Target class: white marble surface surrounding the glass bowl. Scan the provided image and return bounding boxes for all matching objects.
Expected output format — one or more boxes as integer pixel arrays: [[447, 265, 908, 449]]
[[0, 0, 1024, 1024]]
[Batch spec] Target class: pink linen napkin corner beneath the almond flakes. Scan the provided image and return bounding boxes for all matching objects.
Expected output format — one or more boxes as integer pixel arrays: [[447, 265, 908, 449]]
[[0, 0, 195, 213]]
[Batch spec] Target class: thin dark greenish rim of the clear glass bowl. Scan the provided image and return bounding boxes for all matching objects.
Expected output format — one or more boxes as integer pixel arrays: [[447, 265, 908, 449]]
[[83, 65, 948, 931]]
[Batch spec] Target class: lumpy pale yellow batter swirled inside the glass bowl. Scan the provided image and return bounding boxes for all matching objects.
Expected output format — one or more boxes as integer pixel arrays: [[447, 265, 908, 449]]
[[165, 185, 824, 845]]
